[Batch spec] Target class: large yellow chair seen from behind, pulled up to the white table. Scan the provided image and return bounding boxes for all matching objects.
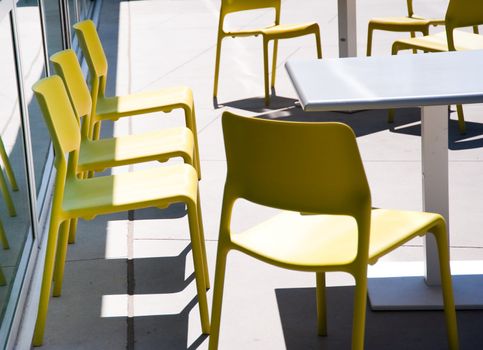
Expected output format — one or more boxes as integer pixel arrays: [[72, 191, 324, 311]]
[[209, 112, 458, 350]]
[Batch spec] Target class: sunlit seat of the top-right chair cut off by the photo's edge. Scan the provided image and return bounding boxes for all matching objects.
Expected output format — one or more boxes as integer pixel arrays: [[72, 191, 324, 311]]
[[394, 30, 483, 52]]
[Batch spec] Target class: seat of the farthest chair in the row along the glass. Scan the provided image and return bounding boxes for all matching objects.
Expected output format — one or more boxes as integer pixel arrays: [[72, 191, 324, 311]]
[[96, 86, 193, 119]]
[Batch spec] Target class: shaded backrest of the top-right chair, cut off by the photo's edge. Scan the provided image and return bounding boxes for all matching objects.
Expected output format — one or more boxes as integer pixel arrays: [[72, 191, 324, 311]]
[[445, 0, 483, 51]]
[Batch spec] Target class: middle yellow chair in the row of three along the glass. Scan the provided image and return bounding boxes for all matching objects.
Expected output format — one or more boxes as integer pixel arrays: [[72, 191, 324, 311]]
[[50, 50, 195, 243]]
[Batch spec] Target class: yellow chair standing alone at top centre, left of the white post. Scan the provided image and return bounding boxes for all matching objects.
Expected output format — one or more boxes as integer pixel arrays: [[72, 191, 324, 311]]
[[213, 0, 322, 106]]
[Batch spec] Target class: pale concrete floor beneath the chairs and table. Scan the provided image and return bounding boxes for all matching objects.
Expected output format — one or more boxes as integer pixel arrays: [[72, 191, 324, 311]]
[[32, 0, 483, 350]]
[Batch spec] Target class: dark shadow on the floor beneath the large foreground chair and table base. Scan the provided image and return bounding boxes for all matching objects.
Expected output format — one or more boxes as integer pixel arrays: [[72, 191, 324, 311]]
[[275, 286, 483, 350]]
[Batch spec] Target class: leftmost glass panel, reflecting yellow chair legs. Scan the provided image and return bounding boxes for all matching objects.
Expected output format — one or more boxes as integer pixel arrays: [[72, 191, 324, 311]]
[[0, 8, 32, 342]]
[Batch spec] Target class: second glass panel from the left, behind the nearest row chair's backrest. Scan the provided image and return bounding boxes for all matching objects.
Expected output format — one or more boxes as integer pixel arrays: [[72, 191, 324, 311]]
[[16, 0, 49, 193]]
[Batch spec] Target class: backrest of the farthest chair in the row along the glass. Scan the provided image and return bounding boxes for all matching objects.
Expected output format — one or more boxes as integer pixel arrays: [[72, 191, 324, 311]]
[[74, 19, 108, 97]]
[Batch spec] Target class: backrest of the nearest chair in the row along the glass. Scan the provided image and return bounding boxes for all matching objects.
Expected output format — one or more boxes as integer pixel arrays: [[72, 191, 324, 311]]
[[32, 75, 81, 160]]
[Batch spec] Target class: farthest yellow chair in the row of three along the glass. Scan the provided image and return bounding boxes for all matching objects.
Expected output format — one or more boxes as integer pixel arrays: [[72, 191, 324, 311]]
[[74, 20, 201, 178]]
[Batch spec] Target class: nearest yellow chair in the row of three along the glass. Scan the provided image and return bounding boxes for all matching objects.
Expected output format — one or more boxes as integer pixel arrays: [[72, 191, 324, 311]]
[[33, 76, 209, 346]]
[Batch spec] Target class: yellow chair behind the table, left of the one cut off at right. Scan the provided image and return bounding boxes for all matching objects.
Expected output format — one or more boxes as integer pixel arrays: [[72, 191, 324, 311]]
[[367, 0, 444, 56]]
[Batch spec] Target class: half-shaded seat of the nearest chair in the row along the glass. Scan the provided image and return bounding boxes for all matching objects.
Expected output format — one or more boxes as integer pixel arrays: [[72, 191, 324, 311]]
[[62, 164, 198, 219]]
